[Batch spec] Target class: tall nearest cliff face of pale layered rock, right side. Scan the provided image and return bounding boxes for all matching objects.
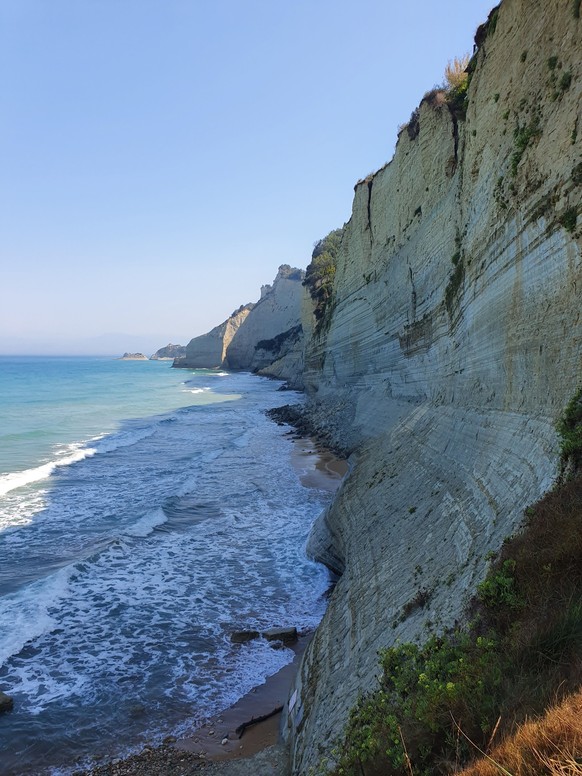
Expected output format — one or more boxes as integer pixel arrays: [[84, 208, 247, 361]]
[[286, 0, 582, 773]]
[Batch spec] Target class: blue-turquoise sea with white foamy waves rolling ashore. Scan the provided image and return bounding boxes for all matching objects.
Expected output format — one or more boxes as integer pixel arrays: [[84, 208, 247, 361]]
[[0, 356, 331, 776]]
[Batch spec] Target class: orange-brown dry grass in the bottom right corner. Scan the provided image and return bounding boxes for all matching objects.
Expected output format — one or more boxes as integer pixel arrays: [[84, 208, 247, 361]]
[[457, 691, 582, 776]]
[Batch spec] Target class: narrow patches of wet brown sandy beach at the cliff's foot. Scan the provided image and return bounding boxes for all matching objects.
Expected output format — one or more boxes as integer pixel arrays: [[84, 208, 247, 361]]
[[81, 431, 348, 776]]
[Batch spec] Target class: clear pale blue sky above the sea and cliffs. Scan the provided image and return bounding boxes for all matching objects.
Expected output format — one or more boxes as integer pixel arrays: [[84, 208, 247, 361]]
[[0, 0, 494, 353]]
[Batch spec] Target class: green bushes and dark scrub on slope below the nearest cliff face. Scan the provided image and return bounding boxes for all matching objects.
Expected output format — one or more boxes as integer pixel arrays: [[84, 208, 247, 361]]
[[322, 394, 582, 776]]
